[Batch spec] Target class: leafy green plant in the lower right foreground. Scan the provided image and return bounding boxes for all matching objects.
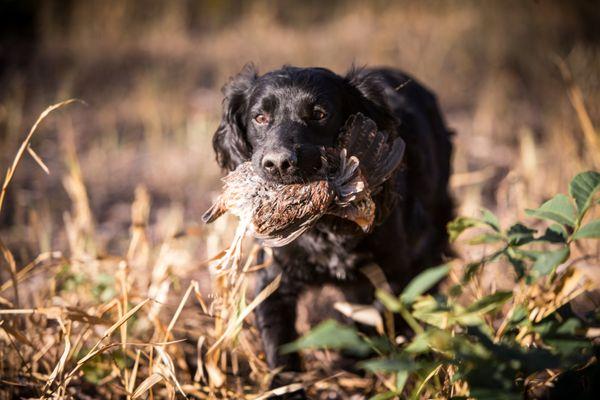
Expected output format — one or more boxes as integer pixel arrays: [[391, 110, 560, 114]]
[[282, 172, 600, 400]]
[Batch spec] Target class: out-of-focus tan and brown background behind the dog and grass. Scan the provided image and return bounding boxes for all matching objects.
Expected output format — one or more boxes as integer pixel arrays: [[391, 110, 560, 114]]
[[0, 0, 600, 260]]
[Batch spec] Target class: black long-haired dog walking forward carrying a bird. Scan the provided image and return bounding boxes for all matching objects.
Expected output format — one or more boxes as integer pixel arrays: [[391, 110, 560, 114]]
[[213, 66, 452, 370]]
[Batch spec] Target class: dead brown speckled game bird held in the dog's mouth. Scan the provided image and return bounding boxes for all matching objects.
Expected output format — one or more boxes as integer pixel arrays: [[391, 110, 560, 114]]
[[202, 113, 405, 247]]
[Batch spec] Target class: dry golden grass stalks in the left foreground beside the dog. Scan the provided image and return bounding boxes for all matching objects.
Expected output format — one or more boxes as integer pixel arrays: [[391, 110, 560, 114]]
[[0, 100, 279, 399]]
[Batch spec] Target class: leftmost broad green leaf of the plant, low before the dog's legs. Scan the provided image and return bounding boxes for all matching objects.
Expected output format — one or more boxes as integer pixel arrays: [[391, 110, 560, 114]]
[[281, 320, 370, 355]]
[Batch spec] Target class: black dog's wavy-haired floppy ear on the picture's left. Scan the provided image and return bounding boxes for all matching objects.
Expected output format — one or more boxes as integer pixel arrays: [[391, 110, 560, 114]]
[[213, 64, 258, 170]]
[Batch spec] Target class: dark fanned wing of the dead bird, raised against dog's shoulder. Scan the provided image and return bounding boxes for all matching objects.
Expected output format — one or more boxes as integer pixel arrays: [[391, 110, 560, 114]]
[[339, 113, 406, 188]]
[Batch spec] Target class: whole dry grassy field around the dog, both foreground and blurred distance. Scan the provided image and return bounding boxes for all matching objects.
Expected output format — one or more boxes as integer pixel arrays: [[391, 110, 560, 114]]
[[0, 0, 600, 399]]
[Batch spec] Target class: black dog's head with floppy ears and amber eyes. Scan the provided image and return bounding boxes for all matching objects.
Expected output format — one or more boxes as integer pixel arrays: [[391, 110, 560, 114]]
[[213, 65, 392, 183]]
